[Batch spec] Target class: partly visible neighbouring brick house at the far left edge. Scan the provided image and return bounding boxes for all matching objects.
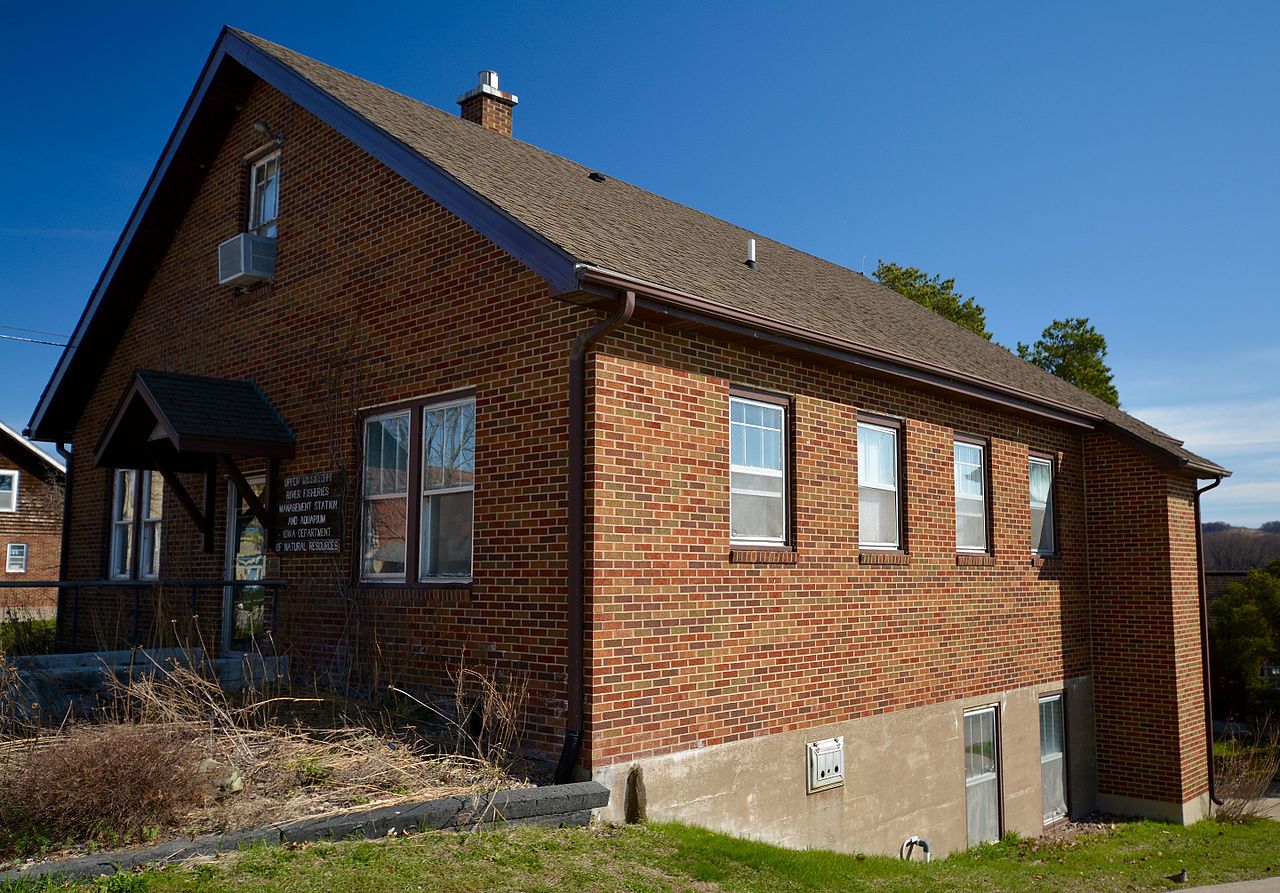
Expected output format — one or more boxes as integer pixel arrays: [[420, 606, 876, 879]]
[[0, 422, 65, 611]]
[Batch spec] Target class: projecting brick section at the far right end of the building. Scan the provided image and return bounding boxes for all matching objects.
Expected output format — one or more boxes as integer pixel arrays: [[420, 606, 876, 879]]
[[1085, 434, 1207, 802]]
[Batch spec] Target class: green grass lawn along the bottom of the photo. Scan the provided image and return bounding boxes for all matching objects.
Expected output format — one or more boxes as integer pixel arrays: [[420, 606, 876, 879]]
[[0, 820, 1280, 893]]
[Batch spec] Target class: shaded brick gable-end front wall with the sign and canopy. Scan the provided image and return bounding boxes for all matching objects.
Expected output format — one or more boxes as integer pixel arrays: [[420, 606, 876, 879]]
[[64, 84, 595, 752]]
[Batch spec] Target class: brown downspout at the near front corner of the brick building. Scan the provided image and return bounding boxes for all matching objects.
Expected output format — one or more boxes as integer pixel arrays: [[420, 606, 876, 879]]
[[556, 290, 636, 784]]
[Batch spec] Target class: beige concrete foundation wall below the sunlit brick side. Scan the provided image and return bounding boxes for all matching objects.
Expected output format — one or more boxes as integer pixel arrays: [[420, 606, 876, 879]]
[[595, 677, 1097, 856]]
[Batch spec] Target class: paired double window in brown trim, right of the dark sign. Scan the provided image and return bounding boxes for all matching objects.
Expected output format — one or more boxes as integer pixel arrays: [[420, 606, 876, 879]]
[[358, 394, 476, 586]]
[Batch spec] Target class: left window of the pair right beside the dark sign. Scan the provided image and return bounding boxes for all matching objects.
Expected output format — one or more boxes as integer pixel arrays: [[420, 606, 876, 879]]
[[360, 409, 412, 581]]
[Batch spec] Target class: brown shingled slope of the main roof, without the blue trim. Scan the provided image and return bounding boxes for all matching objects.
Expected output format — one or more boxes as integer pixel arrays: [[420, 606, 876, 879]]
[[236, 32, 1224, 473]]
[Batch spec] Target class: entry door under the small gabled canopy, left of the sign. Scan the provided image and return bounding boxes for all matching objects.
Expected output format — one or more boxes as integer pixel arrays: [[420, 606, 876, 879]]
[[223, 477, 266, 652]]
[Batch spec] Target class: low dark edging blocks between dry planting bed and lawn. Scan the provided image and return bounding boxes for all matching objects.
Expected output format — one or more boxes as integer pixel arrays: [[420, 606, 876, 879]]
[[0, 782, 609, 883]]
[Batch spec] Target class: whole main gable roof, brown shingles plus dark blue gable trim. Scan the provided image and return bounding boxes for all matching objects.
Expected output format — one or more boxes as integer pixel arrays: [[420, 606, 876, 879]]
[[31, 29, 1230, 477]]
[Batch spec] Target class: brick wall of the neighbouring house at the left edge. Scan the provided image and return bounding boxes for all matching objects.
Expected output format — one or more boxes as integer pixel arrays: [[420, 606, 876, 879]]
[[0, 438, 63, 615]]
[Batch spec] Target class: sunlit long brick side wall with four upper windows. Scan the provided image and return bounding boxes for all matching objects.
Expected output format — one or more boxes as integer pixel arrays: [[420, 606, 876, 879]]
[[590, 326, 1089, 765]]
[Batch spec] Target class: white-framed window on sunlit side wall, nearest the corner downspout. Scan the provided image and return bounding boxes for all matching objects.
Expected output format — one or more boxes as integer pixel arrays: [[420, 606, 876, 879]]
[[728, 395, 787, 545]]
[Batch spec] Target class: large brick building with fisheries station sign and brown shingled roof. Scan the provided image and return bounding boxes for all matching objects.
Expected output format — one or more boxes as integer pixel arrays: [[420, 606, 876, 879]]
[[31, 31, 1228, 852]]
